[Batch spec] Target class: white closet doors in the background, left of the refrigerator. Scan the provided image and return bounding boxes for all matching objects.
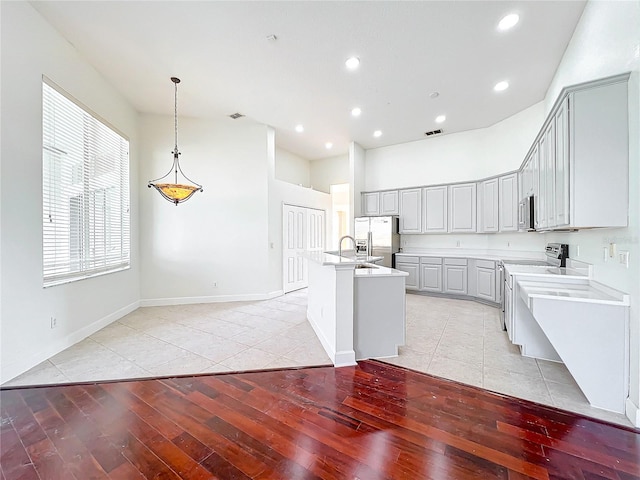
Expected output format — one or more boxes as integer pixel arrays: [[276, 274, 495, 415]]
[[282, 204, 325, 293]]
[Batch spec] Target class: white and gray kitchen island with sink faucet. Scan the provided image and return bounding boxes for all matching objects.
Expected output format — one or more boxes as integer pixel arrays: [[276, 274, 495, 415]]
[[305, 252, 407, 367]]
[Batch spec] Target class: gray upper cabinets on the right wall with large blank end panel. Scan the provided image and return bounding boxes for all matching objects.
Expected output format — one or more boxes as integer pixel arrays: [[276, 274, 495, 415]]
[[520, 74, 629, 231]]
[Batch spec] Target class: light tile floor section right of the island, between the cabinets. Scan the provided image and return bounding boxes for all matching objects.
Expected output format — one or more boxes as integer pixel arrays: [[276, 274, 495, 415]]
[[382, 294, 632, 426]]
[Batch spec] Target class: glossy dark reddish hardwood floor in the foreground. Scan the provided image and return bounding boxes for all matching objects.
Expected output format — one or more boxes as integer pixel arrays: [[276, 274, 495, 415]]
[[0, 361, 640, 480]]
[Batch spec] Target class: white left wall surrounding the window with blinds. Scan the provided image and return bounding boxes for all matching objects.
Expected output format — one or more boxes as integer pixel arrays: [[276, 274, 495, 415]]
[[0, 2, 140, 382]]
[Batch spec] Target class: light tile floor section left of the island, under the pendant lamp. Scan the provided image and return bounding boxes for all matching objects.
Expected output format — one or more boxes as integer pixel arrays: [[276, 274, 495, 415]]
[[3, 290, 331, 387]]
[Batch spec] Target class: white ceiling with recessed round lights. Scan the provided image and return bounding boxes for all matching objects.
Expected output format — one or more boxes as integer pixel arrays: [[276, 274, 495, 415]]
[[32, 1, 585, 159]]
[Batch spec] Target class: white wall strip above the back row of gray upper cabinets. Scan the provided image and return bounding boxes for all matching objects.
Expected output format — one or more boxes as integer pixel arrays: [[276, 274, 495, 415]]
[[364, 102, 544, 191]]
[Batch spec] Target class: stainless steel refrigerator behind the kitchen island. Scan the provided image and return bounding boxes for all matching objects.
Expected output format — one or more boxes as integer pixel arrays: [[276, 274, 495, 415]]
[[355, 216, 400, 268]]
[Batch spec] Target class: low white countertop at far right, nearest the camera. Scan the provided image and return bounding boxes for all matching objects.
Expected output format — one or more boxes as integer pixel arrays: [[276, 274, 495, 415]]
[[518, 280, 630, 305]]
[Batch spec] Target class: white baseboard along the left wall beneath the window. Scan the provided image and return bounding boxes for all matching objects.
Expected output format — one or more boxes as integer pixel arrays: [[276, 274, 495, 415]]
[[0, 301, 140, 385]]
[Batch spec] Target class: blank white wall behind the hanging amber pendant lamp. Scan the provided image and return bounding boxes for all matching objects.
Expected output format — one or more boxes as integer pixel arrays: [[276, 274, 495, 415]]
[[140, 115, 269, 305]]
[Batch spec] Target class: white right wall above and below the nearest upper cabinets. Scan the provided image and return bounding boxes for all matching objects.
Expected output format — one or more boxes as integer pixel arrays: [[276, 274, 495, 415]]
[[544, 1, 640, 426]]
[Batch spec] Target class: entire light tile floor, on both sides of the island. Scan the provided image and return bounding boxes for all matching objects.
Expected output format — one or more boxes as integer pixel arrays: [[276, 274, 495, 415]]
[[3, 290, 631, 426]]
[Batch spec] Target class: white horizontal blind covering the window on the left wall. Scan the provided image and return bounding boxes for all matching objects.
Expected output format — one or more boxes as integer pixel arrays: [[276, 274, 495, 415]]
[[42, 81, 130, 287]]
